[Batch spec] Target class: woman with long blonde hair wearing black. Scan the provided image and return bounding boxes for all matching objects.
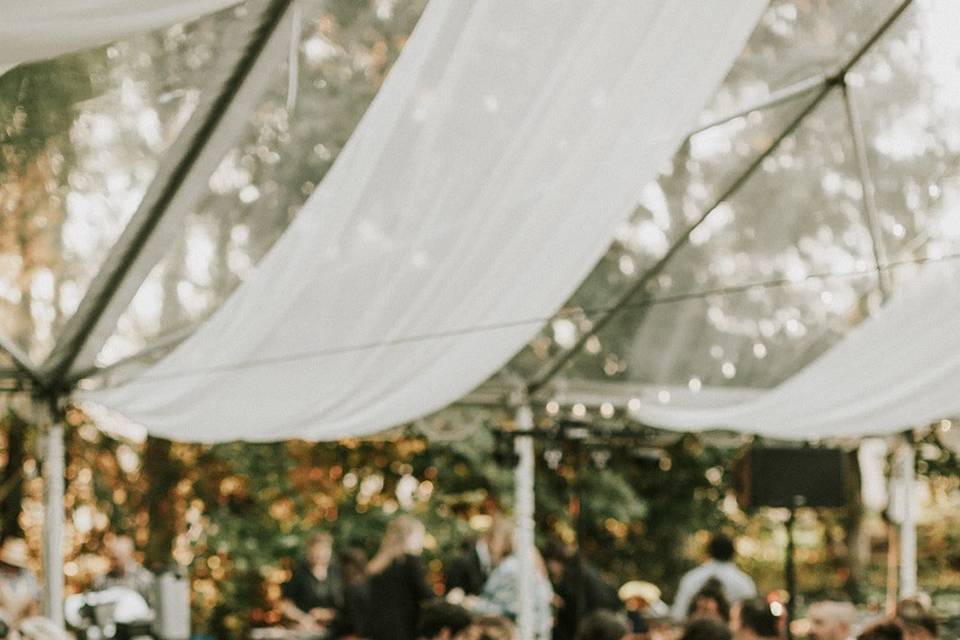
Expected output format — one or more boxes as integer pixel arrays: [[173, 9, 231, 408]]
[[363, 515, 434, 640]]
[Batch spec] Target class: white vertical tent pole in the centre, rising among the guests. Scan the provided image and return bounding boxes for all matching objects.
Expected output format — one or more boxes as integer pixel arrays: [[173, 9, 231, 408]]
[[513, 402, 537, 640]]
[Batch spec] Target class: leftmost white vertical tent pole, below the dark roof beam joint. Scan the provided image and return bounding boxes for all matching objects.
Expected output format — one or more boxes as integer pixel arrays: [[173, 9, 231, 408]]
[[43, 401, 65, 629]]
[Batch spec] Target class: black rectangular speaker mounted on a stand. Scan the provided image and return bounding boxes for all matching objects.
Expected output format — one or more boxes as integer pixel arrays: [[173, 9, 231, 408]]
[[736, 447, 846, 508]]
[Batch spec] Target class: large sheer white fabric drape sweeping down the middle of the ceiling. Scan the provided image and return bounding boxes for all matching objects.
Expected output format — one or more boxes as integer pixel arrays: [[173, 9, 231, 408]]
[[86, 0, 766, 441]]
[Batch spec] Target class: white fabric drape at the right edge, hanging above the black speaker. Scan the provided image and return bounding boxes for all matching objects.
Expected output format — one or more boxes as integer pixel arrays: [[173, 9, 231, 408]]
[[633, 264, 960, 440]]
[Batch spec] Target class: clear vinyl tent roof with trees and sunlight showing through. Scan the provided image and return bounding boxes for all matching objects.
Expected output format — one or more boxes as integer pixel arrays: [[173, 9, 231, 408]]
[[0, 0, 960, 436]]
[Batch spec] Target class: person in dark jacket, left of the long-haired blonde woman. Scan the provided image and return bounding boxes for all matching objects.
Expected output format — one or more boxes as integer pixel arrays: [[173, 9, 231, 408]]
[[280, 532, 343, 631]]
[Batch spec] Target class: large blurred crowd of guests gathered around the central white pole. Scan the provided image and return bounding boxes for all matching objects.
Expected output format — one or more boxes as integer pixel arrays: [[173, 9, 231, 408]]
[[282, 516, 938, 640]]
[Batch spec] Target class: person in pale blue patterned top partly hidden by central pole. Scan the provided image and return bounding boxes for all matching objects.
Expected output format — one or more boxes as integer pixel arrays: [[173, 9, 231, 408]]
[[464, 519, 553, 640]]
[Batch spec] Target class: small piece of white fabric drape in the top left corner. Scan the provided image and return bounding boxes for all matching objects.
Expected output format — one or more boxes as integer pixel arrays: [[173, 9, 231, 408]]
[[0, 0, 240, 75]]
